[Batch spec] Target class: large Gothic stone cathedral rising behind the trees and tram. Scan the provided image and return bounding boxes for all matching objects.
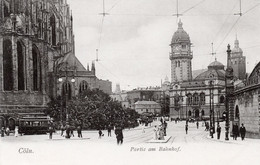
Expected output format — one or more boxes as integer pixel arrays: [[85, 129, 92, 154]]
[[0, 0, 112, 130]]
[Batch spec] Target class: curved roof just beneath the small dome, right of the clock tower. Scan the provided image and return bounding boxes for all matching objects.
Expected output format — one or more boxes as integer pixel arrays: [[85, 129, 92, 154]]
[[195, 69, 225, 80]]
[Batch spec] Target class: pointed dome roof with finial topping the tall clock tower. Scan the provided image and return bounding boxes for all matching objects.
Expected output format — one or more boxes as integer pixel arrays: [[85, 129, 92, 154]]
[[171, 20, 190, 44]]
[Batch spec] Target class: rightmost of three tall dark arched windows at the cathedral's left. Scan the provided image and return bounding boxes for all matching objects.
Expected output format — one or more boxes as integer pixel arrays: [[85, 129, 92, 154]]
[[32, 45, 42, 91]]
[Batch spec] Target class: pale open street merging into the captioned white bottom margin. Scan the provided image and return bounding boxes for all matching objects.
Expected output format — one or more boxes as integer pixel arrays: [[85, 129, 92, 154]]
[[0, 122, 260, 165]]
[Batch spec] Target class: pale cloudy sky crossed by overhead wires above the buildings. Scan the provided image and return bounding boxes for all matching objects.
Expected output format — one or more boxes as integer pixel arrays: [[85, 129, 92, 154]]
[[67, 0, 260, 90]]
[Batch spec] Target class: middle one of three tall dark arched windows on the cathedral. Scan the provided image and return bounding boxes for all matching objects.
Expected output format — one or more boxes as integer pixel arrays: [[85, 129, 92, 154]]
[[17, 41, 25, 90]]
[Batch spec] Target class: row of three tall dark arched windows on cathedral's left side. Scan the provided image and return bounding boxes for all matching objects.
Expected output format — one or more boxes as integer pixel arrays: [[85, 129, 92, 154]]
[[3, 39, 42, 91]]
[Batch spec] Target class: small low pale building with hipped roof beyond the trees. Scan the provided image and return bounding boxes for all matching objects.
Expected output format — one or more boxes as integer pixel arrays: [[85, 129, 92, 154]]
[[135, 101, 161, 115]]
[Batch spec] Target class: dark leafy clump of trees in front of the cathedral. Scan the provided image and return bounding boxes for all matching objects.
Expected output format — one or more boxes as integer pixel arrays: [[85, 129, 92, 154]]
[[46, 89, 139, 129]]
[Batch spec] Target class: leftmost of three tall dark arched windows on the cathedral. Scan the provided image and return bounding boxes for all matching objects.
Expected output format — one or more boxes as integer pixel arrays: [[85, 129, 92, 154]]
[[3, 40, 13, 91]]
